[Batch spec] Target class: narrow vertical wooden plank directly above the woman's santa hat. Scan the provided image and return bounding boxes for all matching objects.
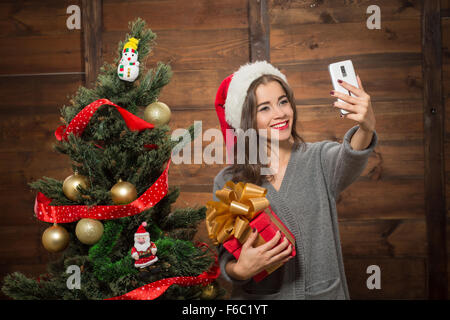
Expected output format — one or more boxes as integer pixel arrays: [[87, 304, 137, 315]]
[[248, 0, 270, 61]]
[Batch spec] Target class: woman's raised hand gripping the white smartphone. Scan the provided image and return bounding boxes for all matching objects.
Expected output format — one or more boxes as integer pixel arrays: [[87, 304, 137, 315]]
[[330, 75, 375, 132]]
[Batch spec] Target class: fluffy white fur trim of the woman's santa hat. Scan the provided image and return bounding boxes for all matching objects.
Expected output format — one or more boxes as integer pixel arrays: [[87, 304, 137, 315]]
[[225, 61, 287, 129]]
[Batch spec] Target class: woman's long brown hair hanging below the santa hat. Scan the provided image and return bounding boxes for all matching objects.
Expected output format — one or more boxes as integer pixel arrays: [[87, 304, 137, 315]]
[[225, 75, 304, 185]]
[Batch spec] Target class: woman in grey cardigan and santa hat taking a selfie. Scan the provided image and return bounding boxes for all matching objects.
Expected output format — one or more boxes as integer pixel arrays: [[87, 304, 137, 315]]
[[213, 61, 377, 299]]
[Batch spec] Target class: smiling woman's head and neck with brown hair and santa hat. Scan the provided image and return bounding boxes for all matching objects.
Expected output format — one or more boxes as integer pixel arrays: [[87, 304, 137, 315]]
[[216, 61, 304, 185]]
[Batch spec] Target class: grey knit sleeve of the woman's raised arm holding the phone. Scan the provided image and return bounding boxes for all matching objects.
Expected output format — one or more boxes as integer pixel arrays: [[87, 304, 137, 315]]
[[320, 126, 378, 198]]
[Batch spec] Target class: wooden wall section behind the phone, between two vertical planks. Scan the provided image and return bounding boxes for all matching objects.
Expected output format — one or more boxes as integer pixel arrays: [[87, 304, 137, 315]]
[[270, 1, 427, 299]]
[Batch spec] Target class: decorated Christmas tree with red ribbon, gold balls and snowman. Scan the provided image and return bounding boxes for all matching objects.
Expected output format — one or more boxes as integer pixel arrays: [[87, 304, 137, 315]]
[[2, 18, 224, 299]]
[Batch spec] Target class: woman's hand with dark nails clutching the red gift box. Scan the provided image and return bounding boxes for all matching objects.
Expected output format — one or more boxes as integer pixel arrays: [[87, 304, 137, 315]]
[[227, 230, 293, 280]]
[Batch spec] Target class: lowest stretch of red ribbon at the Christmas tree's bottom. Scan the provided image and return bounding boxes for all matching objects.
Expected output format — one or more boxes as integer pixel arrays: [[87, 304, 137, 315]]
[[106, 243, 220, 300]]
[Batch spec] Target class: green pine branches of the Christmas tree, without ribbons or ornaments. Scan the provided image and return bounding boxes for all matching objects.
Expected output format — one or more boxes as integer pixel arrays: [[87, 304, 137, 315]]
[[2, 18, 221, 299]]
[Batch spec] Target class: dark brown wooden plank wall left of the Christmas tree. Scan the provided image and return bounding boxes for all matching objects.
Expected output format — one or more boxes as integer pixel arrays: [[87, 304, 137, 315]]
[[0, 0, 84, 297]]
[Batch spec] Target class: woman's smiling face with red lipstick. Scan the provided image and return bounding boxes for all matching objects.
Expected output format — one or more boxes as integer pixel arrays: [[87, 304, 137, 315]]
[[255, 81, 294, 141]]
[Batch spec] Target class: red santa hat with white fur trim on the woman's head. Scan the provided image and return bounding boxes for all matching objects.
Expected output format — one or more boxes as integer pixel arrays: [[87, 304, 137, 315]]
[[215, 61, 287, 132]]
